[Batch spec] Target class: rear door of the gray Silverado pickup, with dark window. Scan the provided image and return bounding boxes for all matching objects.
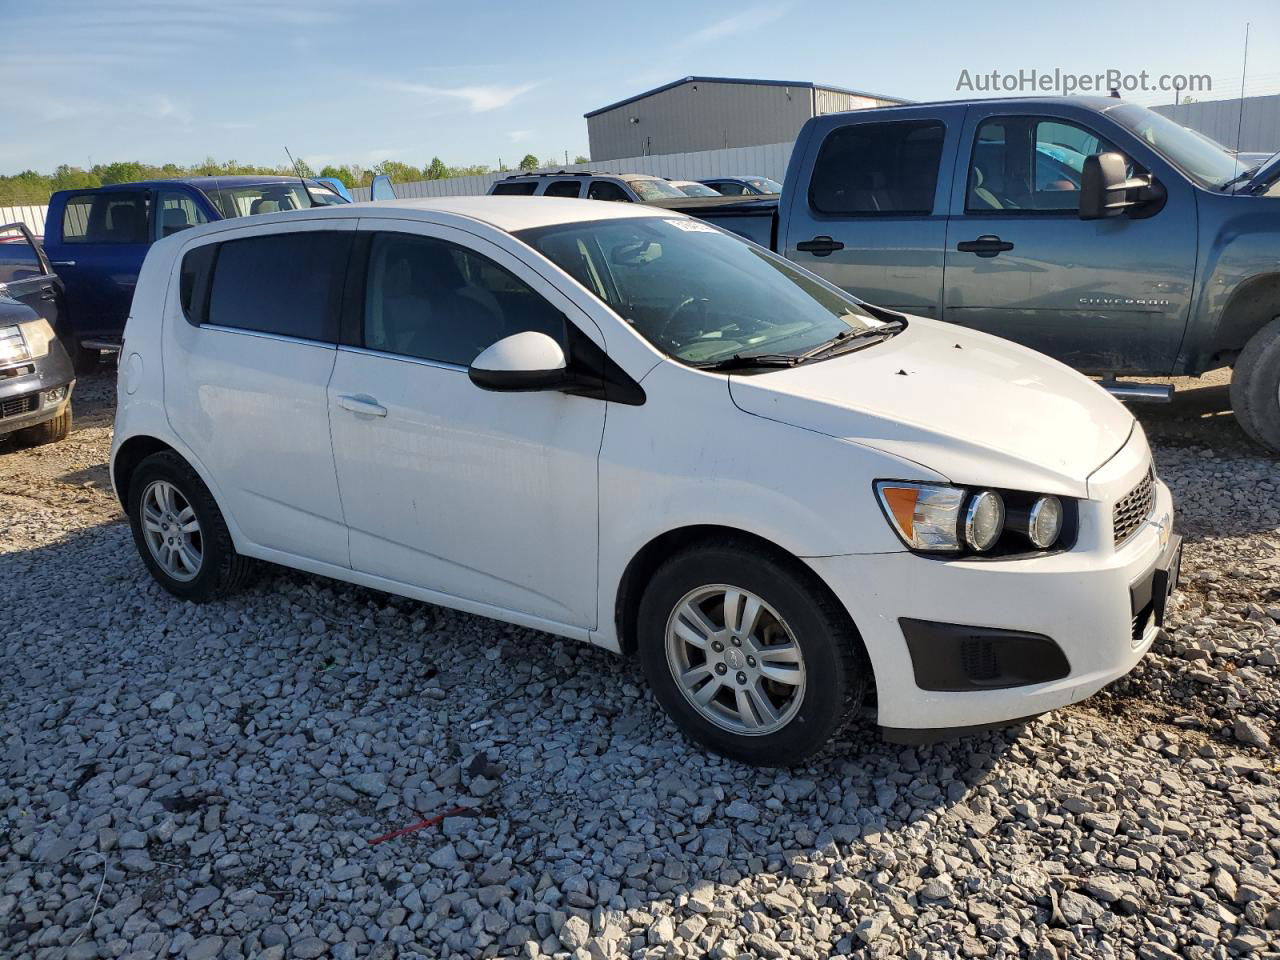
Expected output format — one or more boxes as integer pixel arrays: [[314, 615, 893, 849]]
[[780, 110, 959, 317]]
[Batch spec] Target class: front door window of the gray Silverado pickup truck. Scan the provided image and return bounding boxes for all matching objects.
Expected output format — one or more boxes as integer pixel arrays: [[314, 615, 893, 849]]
[[965, 116, 1114, 214]]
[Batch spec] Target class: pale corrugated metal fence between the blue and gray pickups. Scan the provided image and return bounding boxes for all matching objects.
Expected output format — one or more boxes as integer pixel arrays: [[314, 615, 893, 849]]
[[351, 142, 794, 200]]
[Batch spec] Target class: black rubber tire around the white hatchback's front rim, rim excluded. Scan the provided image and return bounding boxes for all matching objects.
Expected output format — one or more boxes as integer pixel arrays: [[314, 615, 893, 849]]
[[636, 539, 868, 767]]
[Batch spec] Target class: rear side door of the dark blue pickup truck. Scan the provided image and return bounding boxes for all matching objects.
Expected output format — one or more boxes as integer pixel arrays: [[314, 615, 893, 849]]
[[51, 187, 151, 340]]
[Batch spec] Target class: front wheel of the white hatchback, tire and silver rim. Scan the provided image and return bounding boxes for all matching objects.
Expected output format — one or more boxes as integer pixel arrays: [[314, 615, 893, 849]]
[[637, 540, 867, 767]]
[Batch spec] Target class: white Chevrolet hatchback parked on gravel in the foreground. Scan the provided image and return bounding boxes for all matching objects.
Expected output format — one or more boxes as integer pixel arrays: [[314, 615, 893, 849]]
[[111, 197, 1180, 764]]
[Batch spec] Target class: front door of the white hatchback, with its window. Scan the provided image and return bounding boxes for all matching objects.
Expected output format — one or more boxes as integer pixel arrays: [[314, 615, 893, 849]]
[[329, 219, 604, 628]]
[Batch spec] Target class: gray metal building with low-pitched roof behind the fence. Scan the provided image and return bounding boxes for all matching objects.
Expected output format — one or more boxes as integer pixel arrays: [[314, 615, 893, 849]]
[[586, 77, 905, 161]]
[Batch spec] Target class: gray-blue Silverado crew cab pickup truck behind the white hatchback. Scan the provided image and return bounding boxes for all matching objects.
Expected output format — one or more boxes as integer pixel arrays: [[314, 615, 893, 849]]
[[680, 97, 1280, 452]]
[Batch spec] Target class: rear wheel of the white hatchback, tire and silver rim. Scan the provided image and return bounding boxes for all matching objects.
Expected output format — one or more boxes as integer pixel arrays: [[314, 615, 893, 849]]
[[128, 451, 253, 603]]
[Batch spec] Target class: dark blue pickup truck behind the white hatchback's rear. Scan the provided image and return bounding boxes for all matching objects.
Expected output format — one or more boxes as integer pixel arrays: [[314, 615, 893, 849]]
[[44, 177, 348, 372]]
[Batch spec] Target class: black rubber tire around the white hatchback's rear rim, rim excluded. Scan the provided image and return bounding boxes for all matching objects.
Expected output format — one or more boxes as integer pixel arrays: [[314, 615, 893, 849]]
[[128, 451, 253, 603]]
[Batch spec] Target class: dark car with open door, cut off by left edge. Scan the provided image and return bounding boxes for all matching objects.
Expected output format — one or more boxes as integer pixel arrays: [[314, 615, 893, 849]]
[[0, 223, 76, 447]]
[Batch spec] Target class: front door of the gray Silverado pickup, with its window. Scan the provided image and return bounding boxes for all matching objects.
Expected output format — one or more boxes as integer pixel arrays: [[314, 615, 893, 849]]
[[943, 109, 1196, 374]]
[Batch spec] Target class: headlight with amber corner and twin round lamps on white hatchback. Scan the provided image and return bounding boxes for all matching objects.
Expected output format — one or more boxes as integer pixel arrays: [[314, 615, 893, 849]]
[[876, 480, 1075, 556]]
